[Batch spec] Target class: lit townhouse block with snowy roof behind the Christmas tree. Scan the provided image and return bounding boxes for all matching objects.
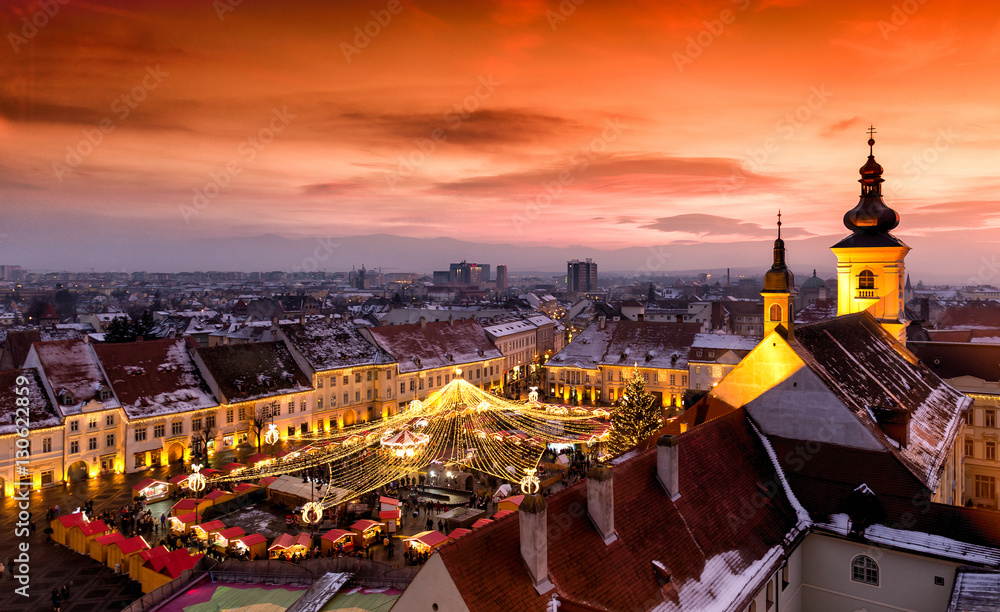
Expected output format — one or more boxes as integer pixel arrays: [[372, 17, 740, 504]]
[[544, 318, 701, 407]]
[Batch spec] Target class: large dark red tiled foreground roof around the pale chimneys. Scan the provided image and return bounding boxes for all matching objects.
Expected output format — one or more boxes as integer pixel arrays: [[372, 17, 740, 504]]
[[440, 410, 798, 612]]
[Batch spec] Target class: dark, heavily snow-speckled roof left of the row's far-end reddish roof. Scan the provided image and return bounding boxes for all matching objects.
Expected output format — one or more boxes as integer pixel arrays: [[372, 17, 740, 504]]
[[281, 319, 384, 372]]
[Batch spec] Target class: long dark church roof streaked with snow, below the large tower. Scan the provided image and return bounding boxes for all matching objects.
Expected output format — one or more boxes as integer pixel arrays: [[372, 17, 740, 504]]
[[790, 312, 972, 490]]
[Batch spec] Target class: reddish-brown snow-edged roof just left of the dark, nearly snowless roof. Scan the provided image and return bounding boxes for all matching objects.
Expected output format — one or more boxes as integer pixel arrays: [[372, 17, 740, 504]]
[[94, 338, 218, 418]]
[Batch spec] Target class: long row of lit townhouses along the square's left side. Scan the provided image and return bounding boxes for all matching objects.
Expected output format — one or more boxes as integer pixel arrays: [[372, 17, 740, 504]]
[[0, 318, 556, 495]]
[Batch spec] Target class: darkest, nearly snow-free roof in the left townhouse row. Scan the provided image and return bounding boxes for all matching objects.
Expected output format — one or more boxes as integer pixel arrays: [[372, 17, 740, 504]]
[[195, 342, 312, 404]]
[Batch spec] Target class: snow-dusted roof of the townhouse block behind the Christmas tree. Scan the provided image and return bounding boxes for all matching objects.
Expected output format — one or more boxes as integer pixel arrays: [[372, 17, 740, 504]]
[[545, 320, 701, 370]]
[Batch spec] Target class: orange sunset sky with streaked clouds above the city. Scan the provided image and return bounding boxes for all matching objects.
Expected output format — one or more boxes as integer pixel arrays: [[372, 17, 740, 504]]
[[0, 0, 1000, 283]]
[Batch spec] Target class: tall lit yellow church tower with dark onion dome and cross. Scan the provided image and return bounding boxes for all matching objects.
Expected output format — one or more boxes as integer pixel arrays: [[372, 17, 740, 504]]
[[831, 128, 910, 342]]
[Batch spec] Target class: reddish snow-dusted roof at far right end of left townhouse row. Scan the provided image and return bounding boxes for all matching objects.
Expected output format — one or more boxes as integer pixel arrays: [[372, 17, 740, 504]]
[[368, 319, 503, 374]]
